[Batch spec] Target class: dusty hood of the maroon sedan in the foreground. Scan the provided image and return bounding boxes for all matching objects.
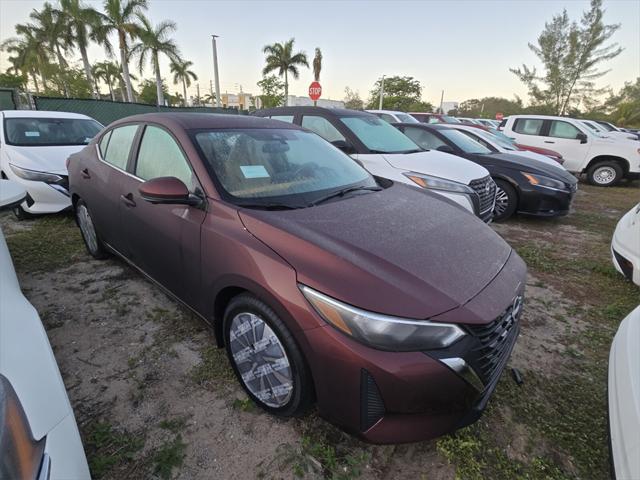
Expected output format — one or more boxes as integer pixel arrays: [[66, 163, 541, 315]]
[[239, 183, 511, 319]]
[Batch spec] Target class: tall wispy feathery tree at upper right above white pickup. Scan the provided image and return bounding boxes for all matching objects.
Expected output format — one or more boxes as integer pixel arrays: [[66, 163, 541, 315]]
[[510, 0, 622, 115]]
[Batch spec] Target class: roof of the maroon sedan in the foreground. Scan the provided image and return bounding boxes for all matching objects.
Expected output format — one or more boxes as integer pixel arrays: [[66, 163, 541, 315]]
[[111, 112, 301, 130]]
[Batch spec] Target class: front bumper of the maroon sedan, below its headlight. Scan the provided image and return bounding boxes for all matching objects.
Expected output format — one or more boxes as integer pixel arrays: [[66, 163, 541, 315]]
[[300, 255, 524, 444]]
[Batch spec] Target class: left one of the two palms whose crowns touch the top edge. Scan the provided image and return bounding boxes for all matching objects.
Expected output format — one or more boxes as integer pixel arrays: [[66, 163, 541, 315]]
[[57, 0, 111, 98]]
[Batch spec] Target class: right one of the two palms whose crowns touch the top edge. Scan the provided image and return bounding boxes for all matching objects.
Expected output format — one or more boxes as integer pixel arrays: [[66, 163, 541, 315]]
[[101, 0, 147, 102]]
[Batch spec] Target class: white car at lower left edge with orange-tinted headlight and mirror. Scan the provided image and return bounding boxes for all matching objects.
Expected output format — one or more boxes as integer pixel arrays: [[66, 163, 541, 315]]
[[0, 180, 91, 480]]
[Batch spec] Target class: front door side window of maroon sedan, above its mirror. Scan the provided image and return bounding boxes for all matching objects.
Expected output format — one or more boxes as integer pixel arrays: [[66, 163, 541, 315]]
[[135, 125, 196, 191]]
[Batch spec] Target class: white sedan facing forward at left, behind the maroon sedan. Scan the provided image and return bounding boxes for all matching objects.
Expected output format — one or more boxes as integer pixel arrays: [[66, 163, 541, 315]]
[[0, 110, 102, 219]]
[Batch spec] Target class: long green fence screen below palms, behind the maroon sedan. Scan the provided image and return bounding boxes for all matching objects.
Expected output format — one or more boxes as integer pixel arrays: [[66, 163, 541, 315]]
[[33, 96, 248, 125]]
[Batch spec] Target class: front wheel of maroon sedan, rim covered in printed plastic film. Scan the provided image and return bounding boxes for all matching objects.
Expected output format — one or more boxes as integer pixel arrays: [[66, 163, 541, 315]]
[[224, 293, 314, 417]]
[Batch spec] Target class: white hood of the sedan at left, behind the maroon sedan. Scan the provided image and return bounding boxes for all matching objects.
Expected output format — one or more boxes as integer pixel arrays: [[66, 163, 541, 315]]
[[3, 145, 86, 175]]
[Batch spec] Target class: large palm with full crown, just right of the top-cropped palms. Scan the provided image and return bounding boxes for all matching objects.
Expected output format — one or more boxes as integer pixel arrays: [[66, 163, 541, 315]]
[[131, 15, 180, 105]]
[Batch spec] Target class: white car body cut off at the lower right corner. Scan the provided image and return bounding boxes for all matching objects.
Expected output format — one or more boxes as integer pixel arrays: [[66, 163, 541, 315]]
[[608, 306, 640, 480]]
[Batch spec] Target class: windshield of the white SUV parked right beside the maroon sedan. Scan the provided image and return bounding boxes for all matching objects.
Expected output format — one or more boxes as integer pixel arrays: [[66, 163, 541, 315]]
[[340, 115, 420, 153]]
